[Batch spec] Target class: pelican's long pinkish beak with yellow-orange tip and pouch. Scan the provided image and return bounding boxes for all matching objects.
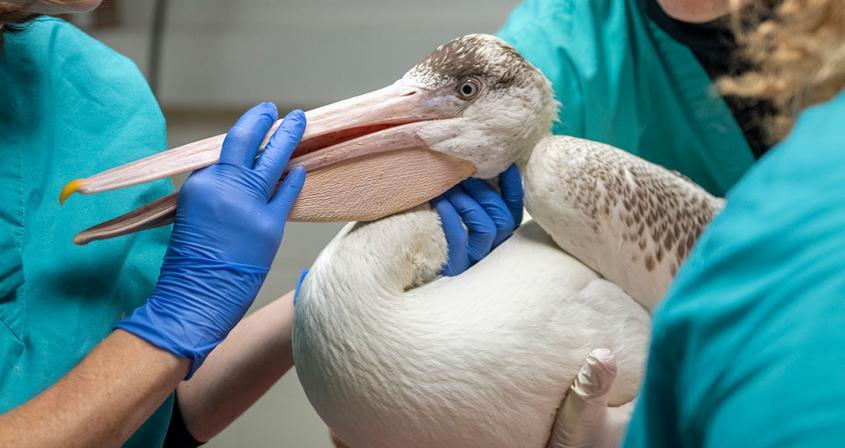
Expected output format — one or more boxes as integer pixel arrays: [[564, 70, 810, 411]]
[[60, 80, 475, 244]]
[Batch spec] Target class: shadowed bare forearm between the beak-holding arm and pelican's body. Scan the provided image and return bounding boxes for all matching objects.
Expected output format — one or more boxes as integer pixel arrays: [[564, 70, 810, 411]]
[[177, 293, 293, 442]]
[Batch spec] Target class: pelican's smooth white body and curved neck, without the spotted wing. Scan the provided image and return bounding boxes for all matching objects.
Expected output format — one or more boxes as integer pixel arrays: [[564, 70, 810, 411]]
[[294, 209, 650, 448]]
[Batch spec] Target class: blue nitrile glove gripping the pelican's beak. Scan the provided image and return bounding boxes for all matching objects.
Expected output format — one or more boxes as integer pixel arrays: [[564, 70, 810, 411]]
[[117, 103, 305, 377]]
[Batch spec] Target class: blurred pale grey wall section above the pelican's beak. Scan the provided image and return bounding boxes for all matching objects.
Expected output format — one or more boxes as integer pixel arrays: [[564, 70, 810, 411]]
[[98, 0, 518, 107]]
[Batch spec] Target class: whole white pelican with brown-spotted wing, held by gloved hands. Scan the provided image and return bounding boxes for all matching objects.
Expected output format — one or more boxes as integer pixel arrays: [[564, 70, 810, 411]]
[[61, 35, 723, 448]]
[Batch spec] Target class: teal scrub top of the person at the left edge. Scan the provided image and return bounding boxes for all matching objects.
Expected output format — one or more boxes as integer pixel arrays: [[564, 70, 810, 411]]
[[0, 18, 172, 447]]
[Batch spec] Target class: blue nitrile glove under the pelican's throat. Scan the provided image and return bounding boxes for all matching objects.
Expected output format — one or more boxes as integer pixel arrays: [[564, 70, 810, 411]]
[[432, 165, 523, 276]]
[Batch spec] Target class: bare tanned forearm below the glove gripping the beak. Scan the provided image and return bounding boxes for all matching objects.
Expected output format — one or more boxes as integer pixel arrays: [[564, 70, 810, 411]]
[[0, 330, 188, 448]]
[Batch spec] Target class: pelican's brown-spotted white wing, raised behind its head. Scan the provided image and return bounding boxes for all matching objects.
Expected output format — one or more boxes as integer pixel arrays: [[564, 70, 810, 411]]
[[525, 137, 723, 309]]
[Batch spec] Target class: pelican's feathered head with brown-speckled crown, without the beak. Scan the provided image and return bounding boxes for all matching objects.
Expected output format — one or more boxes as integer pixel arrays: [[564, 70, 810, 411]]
[[397, 34, 557, 178]]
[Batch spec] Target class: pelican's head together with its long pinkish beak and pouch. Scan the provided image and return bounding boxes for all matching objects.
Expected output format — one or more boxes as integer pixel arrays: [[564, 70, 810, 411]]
[[62, 34, 557, 238]]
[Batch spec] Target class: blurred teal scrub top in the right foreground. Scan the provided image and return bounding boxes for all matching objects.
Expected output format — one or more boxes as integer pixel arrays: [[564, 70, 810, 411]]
[[625, 88, 845, 448]]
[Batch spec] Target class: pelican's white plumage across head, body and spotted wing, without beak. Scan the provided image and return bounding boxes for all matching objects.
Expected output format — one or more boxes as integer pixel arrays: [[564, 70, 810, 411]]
[[294, 36, 721, 448]]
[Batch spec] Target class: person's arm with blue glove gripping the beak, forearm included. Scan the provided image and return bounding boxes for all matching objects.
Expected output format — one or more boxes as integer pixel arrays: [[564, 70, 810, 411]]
[[0, 103, 305, 447]]
